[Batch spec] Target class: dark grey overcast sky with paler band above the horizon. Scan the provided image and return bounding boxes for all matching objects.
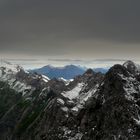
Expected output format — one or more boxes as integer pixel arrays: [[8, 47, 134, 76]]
[[0, 0, 140, 66]]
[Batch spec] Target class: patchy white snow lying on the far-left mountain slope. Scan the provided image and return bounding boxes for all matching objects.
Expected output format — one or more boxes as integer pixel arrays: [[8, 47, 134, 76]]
[[0, 61, 50, 96]]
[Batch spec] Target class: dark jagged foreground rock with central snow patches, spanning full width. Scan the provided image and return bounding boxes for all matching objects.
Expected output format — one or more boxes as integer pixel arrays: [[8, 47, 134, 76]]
[[0, 61, 140, 140]]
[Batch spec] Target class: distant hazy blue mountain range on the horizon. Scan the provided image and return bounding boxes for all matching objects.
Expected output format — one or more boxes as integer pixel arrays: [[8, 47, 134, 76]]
[[29, 65, 108, 80]]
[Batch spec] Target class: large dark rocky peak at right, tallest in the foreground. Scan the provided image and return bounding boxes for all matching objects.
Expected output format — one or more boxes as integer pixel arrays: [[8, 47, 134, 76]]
[[80, 62, 140, 140]]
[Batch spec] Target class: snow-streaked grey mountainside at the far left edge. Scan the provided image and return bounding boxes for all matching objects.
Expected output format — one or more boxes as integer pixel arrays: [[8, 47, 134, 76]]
[[0, 61, 49, 95]]
